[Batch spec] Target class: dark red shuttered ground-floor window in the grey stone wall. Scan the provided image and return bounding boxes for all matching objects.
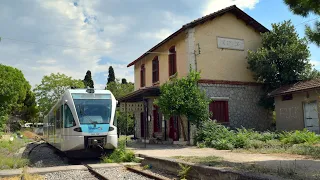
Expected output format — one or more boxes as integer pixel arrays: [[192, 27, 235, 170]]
[[209, 101, 229, 123]]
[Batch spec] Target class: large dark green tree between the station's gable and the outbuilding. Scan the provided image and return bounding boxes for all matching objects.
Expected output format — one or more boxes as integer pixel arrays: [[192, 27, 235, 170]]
[[247, 21, 319, 109]]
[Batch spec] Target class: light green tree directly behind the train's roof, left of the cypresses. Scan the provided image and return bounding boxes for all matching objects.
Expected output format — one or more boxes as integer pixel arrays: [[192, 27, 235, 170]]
[[34, 73, 84, 114]]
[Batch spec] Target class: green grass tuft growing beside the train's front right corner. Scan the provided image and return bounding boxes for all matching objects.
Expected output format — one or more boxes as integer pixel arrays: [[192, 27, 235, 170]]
[[101, 137, 140, 163]]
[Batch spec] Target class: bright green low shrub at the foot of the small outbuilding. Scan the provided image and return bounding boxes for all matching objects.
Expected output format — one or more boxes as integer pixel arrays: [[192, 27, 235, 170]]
[[280, 129, 320, 144]]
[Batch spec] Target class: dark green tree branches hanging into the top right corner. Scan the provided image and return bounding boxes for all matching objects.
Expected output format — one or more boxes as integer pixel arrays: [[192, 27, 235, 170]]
[[284, 0, 320, 46]]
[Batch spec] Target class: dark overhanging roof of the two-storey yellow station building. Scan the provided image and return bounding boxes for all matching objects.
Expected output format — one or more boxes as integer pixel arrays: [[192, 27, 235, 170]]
[[127, 5, 269, 67]]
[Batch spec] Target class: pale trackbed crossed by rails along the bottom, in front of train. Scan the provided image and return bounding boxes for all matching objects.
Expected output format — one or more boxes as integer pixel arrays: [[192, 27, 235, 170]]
[[0, 164, 169, 180]]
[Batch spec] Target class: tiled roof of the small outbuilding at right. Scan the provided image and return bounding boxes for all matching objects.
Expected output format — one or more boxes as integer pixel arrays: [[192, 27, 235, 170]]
[[269, 78, 320, 96]]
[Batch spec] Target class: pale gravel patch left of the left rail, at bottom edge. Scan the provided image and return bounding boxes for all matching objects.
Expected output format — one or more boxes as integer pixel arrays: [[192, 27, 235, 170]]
[[44, 170, 97, 180]]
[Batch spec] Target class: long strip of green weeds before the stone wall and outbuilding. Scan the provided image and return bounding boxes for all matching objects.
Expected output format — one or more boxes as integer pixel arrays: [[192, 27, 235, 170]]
[[196, 121, 320, 158]]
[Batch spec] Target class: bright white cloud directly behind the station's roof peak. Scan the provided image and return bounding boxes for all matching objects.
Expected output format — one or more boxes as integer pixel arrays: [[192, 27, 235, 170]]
[[202, 0, 259, 15]]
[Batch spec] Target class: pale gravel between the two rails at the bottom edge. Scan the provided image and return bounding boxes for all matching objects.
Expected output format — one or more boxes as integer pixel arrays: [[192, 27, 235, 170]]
[[96, 167, 154, 180]]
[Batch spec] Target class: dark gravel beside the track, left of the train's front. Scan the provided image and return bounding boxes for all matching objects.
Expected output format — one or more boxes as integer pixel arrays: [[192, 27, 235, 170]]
[[27, 143, 68, 167]]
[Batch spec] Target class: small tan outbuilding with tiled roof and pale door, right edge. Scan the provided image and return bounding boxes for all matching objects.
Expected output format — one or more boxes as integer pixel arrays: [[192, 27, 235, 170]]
[[269, 79, 320, 133]]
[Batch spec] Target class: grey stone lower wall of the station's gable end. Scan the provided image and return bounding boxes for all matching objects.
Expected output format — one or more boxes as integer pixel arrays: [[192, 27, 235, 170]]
[[199, 83, 272, 130]]
